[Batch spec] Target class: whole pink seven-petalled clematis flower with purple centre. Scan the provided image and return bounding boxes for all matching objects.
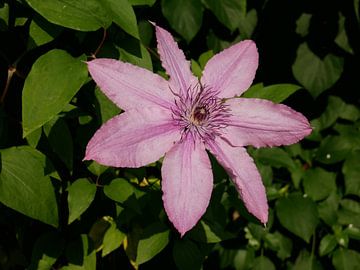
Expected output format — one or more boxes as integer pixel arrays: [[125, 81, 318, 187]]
[[85, 26, 311, 235]]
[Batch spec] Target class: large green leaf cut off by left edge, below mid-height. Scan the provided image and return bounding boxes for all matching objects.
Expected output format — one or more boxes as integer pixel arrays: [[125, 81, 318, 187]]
[[0, 146, 58, 227]]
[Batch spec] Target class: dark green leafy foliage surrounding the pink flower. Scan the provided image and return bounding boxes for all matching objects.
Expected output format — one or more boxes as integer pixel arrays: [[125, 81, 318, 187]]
[[0, 0, 360, 270]]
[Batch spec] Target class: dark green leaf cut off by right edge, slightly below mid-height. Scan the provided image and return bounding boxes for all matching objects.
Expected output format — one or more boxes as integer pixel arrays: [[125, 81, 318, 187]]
[[342, 150, 360, 197]]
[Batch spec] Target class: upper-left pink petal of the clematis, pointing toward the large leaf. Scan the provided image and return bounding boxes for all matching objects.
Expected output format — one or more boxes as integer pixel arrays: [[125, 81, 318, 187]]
[[87, 58, 174, 110]]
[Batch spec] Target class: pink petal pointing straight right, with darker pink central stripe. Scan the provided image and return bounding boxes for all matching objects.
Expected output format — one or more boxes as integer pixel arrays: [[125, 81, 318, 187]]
[[222, 98, 311, 147]]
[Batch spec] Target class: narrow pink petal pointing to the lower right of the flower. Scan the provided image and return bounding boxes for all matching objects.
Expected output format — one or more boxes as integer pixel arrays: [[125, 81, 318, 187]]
[[207, 138, 268, 224]]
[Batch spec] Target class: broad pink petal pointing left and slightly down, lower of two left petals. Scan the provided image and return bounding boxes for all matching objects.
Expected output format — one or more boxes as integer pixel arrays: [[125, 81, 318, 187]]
[[85, 107, 181, 167]]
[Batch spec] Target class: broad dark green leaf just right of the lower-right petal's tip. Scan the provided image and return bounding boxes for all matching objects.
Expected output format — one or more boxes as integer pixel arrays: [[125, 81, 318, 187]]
[[276, 194, 319, 243]]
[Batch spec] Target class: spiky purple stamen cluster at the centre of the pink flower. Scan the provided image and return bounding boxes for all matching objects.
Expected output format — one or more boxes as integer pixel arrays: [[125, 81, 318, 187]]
[[172, 84, 230, 141]]
